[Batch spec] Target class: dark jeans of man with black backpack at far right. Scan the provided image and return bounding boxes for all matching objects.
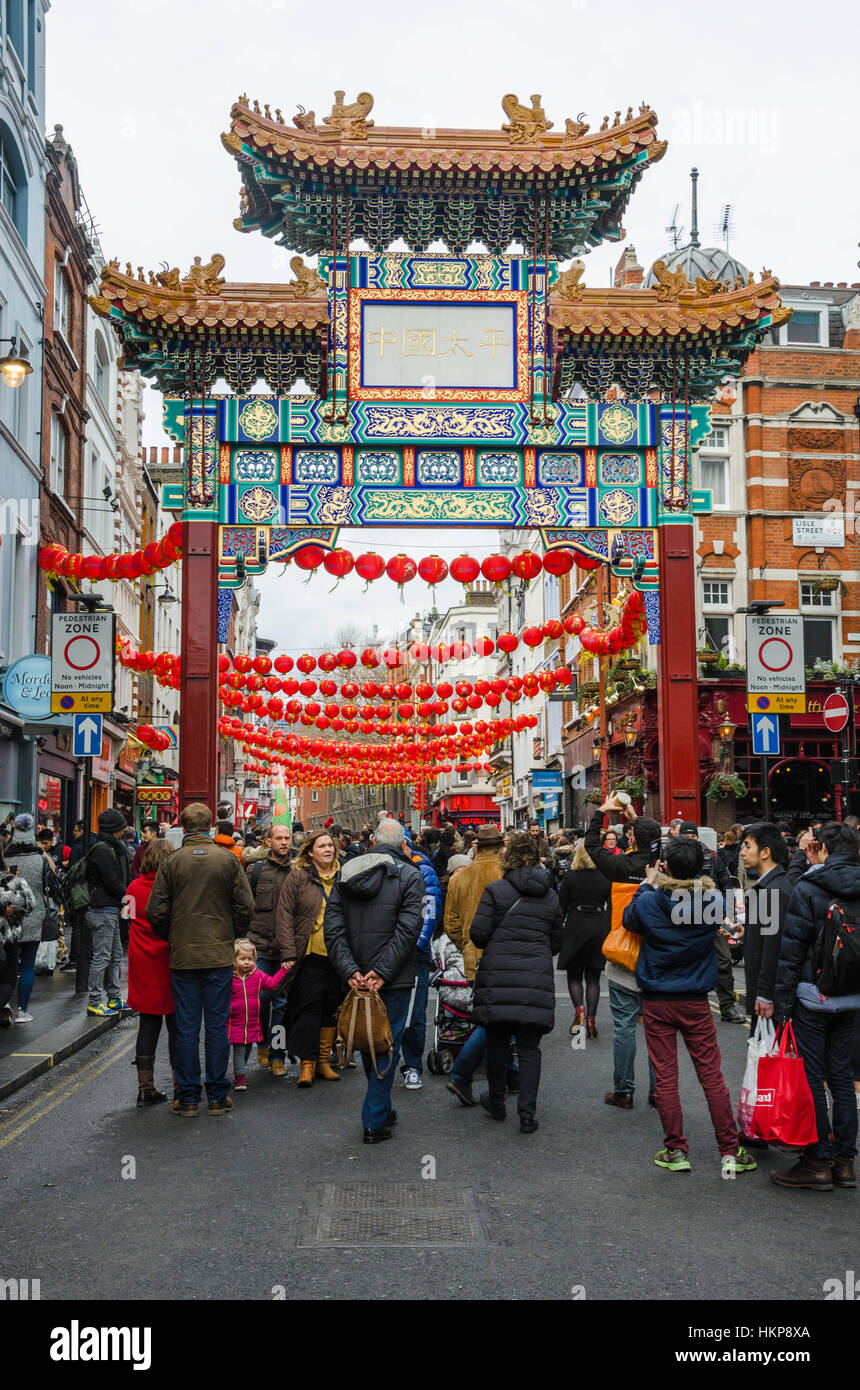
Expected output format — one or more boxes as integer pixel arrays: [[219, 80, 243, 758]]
[[792, 1001, 857, 1158]]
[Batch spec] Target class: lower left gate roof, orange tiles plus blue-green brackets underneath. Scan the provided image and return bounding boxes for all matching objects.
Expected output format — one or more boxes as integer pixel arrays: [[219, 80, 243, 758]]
[[90, 254, 328, 392]]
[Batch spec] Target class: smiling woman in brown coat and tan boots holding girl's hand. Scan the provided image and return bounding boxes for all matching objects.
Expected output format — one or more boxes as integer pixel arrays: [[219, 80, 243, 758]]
[[275, 830, 343, 1087]]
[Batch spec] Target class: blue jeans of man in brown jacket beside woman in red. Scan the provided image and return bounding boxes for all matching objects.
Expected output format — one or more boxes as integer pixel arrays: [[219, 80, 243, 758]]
[[171, 965, 233, 1105]]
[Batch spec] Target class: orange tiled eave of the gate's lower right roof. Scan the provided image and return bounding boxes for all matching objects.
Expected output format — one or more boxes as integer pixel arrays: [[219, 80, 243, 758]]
[[549, 263, 791, 345]]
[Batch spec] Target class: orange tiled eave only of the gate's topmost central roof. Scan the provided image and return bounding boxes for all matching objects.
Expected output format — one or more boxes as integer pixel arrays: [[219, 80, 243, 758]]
[[221, 99, 665, 177]]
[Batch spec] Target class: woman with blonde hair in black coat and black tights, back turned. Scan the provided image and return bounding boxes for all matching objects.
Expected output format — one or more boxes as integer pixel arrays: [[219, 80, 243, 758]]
[[557, 840, 611, 1038]]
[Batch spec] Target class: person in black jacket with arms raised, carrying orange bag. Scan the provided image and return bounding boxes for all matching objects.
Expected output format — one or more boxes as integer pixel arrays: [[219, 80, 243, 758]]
[[585, 796, 660, 1111]]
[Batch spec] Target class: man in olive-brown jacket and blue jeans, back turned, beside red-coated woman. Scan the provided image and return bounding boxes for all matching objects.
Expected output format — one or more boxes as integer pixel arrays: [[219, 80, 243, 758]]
[[146, 801, 254, 1119]]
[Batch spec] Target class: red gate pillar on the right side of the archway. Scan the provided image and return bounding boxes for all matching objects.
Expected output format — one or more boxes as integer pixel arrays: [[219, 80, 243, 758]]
[[657, 524, 702, 826]]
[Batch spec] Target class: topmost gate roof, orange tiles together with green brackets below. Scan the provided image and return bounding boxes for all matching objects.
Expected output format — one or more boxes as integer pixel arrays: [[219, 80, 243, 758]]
[[221, 92, 665, 260]]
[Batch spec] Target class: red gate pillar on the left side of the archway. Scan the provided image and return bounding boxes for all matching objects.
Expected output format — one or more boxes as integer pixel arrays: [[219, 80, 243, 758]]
[[179, 521, 218, 816]]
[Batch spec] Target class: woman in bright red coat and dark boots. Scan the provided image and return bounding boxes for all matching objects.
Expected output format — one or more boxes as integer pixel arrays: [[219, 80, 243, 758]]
[[126, 840, 178, 1109]]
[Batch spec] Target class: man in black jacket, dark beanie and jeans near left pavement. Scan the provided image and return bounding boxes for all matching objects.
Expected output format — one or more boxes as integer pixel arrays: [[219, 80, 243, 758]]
[[86, 808, 132, 1017]]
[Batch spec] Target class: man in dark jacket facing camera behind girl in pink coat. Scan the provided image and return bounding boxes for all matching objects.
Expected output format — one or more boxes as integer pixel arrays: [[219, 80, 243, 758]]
[[247, 826, 295, 1077]]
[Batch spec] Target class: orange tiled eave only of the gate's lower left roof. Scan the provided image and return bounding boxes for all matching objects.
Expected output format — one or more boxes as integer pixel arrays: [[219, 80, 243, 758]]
[[90, 257, 328, 336]]
